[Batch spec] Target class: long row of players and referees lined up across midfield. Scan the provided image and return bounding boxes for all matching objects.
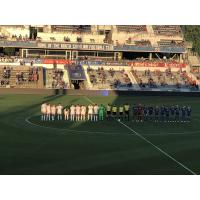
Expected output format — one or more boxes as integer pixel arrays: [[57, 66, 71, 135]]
[[41, 103, 192, 122]]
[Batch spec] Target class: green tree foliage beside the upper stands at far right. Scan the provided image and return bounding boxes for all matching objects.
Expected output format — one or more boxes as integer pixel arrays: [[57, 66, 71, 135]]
[[182, 25, 200, 55]]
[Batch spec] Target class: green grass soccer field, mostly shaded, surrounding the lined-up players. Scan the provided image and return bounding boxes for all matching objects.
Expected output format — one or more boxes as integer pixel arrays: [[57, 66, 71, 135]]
[[0, 95, 200, 174]]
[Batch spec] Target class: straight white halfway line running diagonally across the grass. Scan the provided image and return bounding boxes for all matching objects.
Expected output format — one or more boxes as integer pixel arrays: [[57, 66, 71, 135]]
[[86, 96, 197, 175]]
